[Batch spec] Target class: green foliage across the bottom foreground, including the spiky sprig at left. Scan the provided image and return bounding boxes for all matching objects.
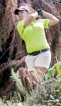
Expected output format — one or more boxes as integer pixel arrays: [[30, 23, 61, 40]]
[[0, 62, 61, 106]]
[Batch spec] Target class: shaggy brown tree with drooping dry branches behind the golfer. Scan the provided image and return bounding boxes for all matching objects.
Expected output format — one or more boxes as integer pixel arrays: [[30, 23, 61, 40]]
[[0, 0, 61, 99]]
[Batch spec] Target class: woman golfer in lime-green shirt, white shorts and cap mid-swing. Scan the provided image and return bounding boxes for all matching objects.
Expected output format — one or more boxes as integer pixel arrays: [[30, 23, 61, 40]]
[[15, 4, 59, 89]]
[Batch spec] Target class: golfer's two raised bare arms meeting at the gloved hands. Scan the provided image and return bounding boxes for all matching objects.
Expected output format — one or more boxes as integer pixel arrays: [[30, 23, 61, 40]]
[[24, 9, 59, 27]]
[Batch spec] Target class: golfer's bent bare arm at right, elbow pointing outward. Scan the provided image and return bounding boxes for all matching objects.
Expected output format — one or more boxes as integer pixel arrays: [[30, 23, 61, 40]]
[[42, 11, 59, 27]]
